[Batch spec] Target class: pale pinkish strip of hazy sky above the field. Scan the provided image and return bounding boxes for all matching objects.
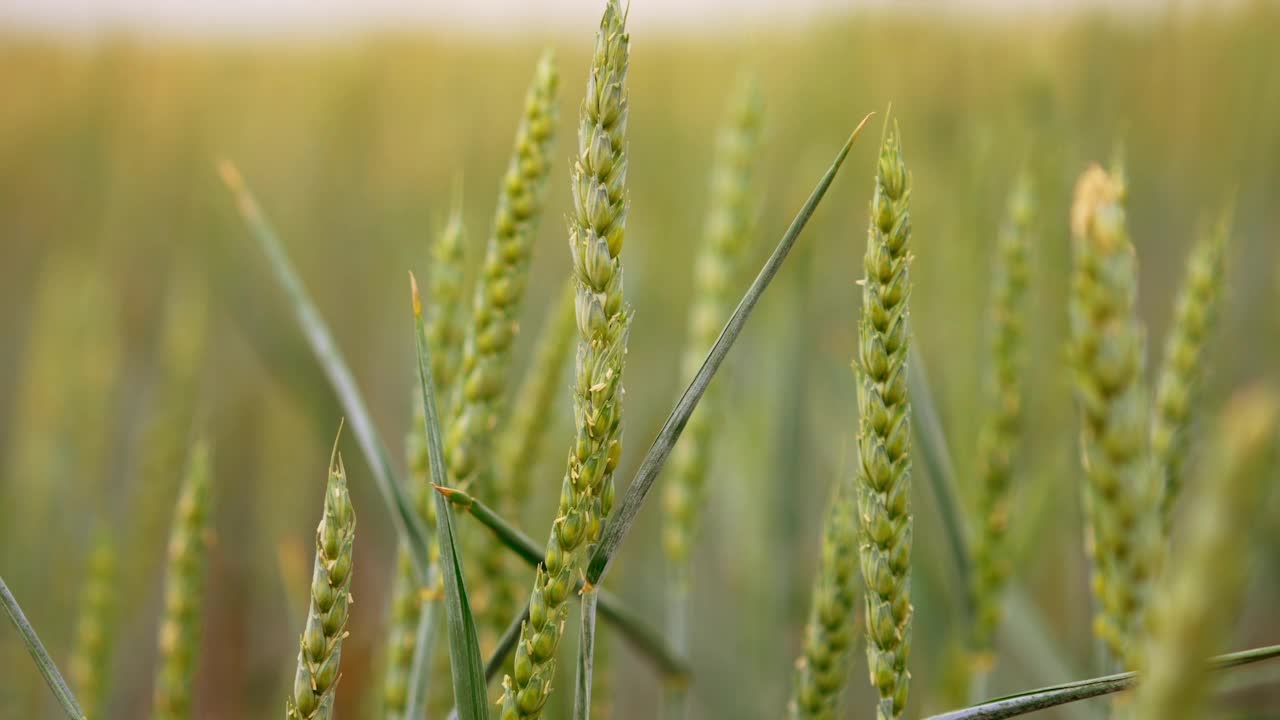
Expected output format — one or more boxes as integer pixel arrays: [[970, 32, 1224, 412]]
[[0, 0, 1165, 35]]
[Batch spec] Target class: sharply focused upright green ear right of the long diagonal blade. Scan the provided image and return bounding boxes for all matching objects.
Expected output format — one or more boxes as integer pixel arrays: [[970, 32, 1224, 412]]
[[854, 117, 913, 720]]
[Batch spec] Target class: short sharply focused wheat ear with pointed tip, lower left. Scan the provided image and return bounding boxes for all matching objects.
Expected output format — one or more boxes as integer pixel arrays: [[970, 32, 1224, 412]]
[[285, 442, 356, 720]]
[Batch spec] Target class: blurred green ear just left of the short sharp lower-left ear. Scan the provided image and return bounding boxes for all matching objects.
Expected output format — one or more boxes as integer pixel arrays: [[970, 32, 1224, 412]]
[[151, 442, 210, 720]]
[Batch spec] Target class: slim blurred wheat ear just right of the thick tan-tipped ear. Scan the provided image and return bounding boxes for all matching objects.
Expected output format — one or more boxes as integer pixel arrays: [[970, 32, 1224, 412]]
[[1151, 210, 1230, 534]]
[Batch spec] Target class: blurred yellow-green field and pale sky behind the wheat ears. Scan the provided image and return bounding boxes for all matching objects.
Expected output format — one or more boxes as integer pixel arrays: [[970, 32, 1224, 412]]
[[0, 0, 1280, 719]]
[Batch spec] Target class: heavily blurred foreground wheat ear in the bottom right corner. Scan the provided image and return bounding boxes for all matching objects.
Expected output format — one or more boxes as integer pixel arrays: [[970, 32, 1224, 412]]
[[1132, 388, 1280, 720]]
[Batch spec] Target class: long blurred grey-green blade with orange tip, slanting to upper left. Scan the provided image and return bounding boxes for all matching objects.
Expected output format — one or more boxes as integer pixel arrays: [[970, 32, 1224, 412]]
[[219, 161, 430, 583]]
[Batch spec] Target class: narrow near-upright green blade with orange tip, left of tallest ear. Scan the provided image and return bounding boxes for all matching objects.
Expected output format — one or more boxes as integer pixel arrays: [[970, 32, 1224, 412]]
[[410, 273, 489, 720]]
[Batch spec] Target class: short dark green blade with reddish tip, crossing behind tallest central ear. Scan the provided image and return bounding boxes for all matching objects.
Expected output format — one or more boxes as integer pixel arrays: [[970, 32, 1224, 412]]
[[435, 487, 689, 682]]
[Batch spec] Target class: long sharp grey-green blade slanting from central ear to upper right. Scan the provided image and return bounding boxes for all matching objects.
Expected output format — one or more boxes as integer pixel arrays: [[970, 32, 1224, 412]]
[[586, 113, 874, 585]]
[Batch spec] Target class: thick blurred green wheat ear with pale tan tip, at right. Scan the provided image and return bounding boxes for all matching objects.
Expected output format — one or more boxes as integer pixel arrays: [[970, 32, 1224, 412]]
[[1069, 165, 1161, 667]]
